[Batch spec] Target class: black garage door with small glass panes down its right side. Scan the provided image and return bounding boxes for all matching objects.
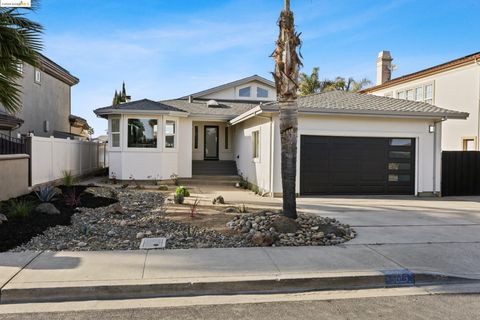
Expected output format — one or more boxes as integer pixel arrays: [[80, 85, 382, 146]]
[[300, 135, 415, 195]]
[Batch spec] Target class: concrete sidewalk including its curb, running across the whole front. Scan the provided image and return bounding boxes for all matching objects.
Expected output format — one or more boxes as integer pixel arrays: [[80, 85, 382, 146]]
[[0, 243, 480, 303]]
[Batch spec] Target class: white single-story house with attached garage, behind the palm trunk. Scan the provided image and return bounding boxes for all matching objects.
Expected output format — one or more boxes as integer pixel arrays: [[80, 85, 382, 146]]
[[95, 76, 468, 196]]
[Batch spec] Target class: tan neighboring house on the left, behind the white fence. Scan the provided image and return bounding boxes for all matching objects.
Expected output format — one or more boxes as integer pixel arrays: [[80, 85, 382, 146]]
[[0, 54, 89, 138]]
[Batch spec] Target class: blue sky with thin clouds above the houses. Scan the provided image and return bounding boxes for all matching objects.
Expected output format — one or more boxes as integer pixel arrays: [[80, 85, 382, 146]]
[[31, 0, 480, 136]]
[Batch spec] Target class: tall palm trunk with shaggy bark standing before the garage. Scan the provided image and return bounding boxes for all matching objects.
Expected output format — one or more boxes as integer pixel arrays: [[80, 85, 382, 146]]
[[272, 0, 302, 219]]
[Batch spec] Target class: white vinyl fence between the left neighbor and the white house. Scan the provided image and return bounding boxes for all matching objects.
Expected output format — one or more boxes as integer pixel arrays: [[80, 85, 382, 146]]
[[31, 136, 108, 186]]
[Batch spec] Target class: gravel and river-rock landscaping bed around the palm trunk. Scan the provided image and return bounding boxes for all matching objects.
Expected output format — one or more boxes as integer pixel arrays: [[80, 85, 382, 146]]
[[12, 187, 356, 251]]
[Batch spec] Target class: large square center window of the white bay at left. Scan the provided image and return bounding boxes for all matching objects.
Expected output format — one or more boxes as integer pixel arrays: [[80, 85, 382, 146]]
[[128, 119, 158, 148]]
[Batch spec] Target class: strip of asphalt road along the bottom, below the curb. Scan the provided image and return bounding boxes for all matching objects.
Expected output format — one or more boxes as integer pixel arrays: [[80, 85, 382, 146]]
[[0, 294, 480, 320]]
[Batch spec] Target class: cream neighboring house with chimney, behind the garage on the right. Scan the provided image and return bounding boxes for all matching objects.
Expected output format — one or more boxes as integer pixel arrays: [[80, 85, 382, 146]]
[[362, 51, 480, 151]]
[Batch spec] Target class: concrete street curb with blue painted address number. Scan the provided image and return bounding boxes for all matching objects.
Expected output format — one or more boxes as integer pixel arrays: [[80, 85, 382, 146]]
[[0, 270, 480, 304]]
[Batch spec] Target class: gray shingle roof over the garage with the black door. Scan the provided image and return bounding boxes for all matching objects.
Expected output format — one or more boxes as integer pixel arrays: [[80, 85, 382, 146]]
[[262, 91, 468, 119]]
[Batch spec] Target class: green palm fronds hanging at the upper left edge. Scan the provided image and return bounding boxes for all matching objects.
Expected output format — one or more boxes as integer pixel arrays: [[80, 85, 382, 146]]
[[0, 0, 43, 113]]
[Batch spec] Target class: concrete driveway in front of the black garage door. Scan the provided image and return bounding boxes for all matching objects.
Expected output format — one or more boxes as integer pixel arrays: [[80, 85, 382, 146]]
[[298, 197, 480, 244]]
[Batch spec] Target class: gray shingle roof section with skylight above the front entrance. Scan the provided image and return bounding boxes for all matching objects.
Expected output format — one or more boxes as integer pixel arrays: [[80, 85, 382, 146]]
[[160, 99, 260, 120]]
